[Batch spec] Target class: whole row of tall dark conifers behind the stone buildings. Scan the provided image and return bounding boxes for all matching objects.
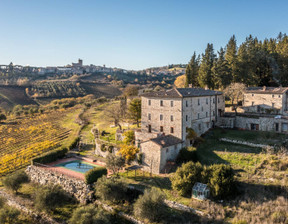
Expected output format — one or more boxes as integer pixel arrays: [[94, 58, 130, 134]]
[[185, 32, 288, 89]]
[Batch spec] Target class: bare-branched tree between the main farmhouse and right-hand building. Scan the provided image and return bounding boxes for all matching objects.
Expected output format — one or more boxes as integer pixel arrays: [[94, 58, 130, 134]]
[[224, 83, 246, 115]]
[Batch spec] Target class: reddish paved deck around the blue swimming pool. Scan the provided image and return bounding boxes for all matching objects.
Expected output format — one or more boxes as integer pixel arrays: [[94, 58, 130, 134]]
[[45, 157, 105, 180]]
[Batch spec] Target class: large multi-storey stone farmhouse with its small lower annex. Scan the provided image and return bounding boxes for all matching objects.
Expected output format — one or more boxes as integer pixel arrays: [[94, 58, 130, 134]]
[[135, 88, 225, 173]]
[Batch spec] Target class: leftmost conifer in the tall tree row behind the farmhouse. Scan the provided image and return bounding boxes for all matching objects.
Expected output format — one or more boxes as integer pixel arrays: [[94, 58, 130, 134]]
[[185, 51, 199, 87]]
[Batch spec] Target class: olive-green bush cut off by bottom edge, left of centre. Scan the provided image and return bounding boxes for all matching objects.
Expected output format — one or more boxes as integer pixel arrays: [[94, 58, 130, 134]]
[[69, 205, 111, 224]]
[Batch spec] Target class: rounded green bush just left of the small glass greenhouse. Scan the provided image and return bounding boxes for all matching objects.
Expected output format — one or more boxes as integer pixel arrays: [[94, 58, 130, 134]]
[[171, 162, 203, 195]]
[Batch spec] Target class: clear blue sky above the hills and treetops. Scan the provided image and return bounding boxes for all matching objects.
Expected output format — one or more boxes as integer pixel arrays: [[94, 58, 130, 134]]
[[0, 0, 288, 70]]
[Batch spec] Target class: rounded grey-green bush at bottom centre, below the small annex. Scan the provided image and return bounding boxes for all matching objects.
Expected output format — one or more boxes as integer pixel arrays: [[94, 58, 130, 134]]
[[134, 188, 166, 222]]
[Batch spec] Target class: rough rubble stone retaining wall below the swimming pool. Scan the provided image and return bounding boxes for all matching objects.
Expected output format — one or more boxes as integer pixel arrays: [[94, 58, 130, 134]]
[[25, 165, 93, 203]]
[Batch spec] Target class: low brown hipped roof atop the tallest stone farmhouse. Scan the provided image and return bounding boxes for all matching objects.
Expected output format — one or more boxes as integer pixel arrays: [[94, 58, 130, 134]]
[[142, 88, 222, 98]]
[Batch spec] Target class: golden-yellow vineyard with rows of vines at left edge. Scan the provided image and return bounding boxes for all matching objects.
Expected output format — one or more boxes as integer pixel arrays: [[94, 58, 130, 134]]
[[0, 108, 82, 176]]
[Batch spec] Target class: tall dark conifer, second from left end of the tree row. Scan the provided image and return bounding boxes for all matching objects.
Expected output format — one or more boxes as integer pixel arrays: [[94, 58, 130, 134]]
[[198, 43, 215, 89]]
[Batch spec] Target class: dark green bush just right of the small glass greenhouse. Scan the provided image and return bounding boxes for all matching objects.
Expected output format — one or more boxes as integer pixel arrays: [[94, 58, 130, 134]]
[[208, 164, 235, 198]]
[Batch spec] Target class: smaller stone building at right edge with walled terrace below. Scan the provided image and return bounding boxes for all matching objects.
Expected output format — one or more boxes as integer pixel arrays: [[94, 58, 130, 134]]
[[219, 86, 288, 133]]
